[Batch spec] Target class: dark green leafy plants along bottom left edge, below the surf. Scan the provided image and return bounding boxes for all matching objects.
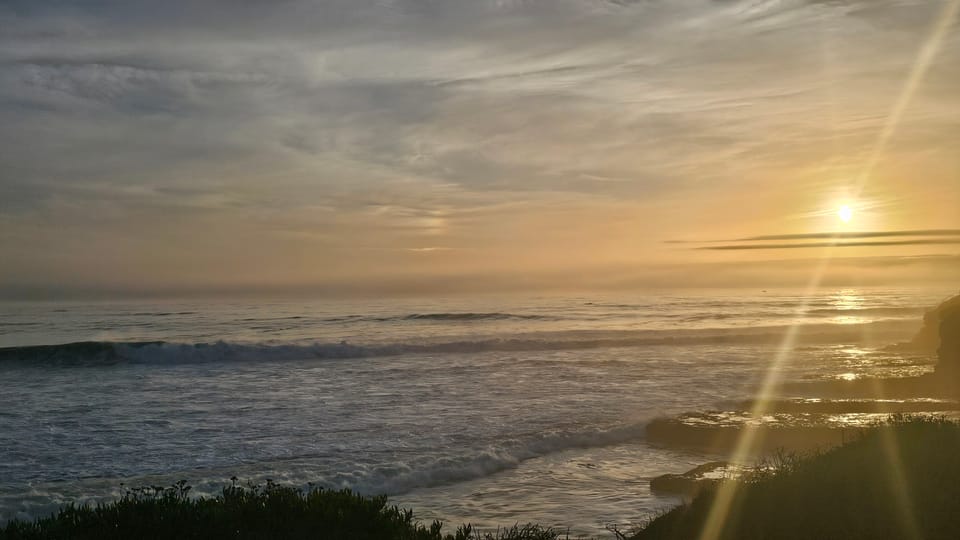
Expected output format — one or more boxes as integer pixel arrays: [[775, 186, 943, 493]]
[[0, 479, 560, 540]]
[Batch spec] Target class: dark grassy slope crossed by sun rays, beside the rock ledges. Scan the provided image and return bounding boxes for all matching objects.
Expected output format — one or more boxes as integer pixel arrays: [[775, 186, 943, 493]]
[[633, 418, 960, 540]]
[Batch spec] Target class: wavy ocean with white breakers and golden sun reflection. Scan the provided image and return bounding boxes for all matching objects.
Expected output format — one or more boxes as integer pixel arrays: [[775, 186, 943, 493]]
[[0, 289, 954, 536]]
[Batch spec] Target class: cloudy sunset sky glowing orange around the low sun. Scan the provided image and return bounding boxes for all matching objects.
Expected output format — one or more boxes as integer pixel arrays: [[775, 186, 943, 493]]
[[0, 0, 960, 297]]
